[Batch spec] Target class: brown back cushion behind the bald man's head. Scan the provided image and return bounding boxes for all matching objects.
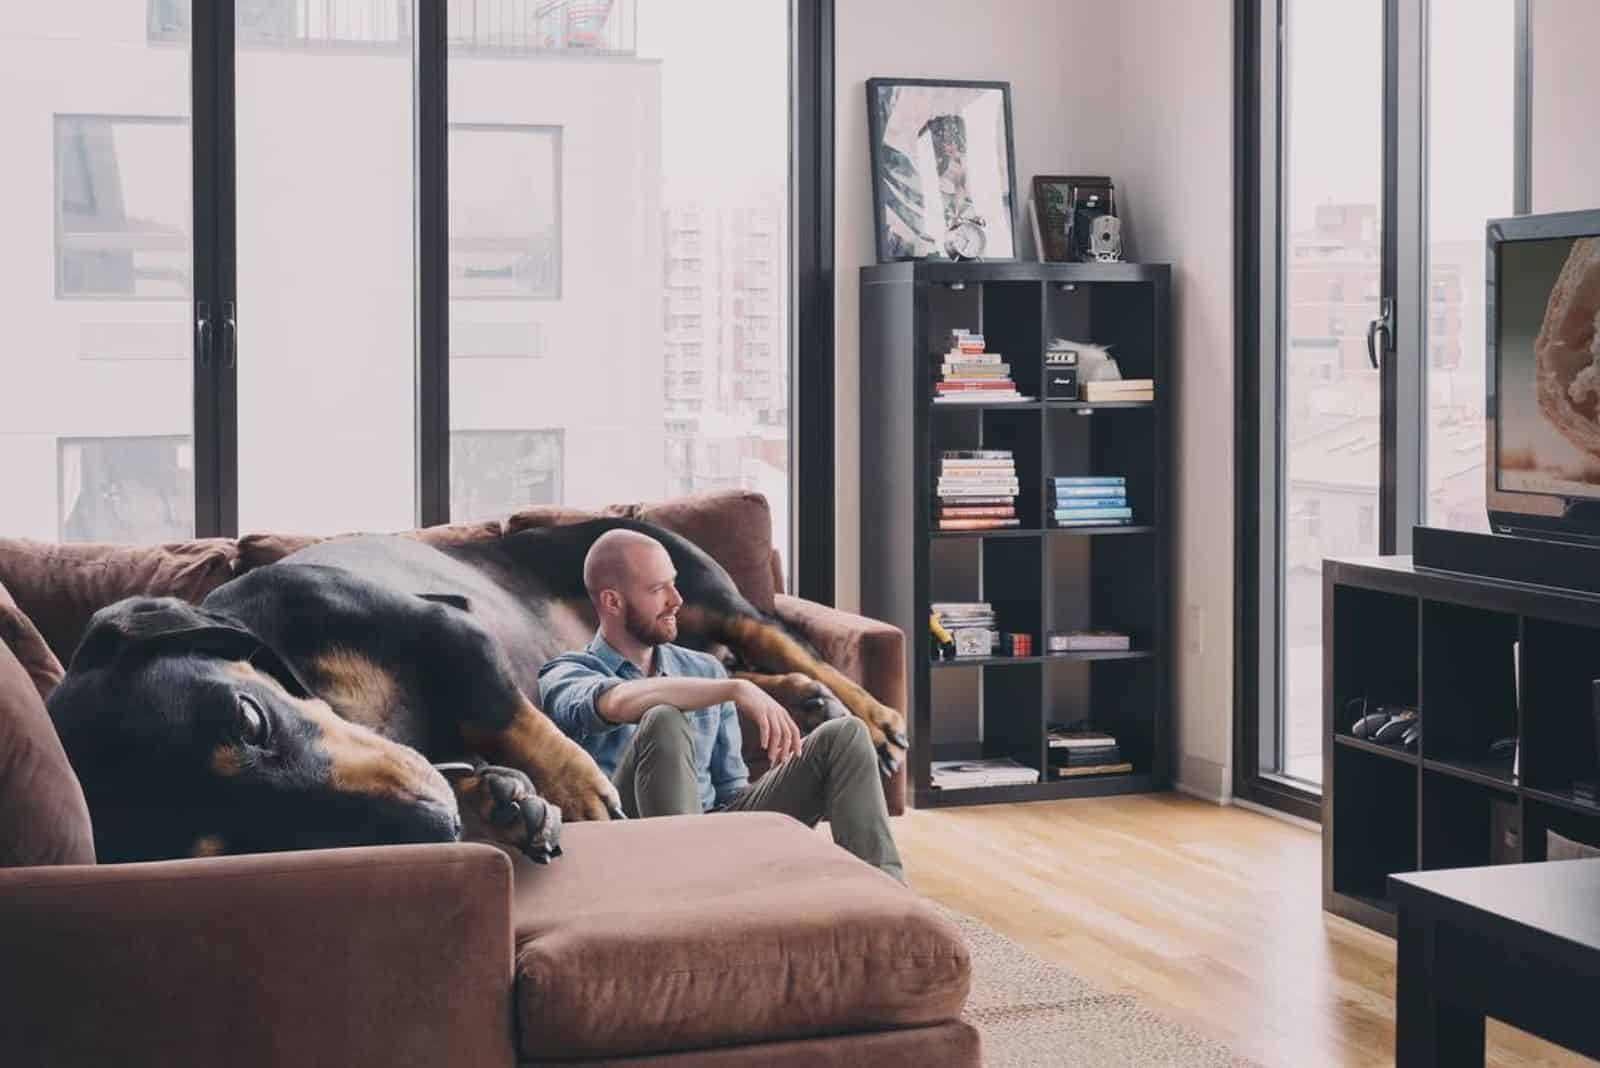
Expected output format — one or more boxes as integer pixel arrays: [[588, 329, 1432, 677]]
[[506, 489, 773, 614]]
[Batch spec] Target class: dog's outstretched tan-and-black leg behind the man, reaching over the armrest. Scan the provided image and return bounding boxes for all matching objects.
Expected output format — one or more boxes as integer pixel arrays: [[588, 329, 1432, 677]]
[[678, 604, 910, 775]]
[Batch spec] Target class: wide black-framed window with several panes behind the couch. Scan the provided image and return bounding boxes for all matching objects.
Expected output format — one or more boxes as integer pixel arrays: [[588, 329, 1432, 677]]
[[0, 0, 834, 585]]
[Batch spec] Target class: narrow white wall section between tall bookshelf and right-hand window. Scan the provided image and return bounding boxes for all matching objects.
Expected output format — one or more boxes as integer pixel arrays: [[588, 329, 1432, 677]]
[[1109, 0, 1234, 799]]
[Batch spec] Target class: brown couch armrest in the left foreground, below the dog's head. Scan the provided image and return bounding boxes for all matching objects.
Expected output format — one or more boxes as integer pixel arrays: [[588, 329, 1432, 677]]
[[0, 844, 515, 1068]]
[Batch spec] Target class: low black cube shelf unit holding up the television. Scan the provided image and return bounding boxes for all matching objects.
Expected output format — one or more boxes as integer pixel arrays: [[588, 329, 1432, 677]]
[[1322, 556, 1600, 935]]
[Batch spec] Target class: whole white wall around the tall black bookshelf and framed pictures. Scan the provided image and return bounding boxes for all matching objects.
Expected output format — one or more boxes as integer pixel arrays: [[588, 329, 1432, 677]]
[[834, 0, 1234, 799]]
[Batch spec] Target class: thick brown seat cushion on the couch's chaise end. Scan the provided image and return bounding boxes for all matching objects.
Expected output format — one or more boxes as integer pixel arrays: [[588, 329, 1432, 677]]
[[512, 812, 970, 1060]]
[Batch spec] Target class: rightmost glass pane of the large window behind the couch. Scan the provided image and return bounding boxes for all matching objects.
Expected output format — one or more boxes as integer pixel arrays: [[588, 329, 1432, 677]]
[[450, 0, 789, 578]]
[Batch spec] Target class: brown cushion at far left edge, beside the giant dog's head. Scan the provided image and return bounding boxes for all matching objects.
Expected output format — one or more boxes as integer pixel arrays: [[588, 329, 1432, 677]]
[[0, 643, 94, 868]]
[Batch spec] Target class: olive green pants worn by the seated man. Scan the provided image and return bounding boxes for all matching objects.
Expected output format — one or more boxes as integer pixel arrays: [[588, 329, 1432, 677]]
[[613, 705, 906, 883]]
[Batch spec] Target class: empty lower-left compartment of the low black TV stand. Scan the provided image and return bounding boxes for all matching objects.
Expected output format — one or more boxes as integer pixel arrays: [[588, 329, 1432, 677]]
[[1323, 739, 1418, 900]]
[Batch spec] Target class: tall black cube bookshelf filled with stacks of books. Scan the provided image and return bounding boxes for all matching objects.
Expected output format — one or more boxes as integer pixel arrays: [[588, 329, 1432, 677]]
[[861, 262, 1174, 807]]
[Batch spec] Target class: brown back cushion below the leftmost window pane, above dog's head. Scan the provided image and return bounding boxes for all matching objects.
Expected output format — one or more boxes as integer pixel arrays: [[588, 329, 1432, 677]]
[[0, 537, 238, 667]]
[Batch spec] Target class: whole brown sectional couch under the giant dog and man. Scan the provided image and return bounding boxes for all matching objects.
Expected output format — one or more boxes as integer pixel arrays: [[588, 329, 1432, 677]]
[[0, 494, 979, 1068]]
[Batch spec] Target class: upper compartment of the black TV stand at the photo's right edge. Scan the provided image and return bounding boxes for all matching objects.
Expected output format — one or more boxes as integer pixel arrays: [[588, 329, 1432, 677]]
[[1510, 619, 1600, 795]]
